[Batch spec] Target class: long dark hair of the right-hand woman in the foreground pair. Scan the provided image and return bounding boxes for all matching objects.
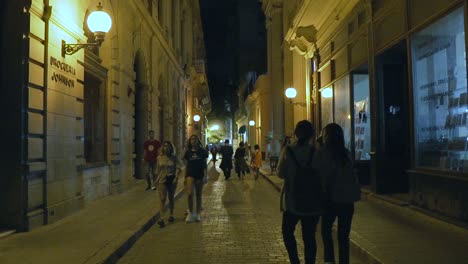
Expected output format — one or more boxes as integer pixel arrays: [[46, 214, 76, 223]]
[[322, 123, 350, 166]]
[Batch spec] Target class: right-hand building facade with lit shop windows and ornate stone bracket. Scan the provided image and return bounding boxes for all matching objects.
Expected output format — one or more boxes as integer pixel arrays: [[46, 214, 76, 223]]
[[262, 0, 468, 223]]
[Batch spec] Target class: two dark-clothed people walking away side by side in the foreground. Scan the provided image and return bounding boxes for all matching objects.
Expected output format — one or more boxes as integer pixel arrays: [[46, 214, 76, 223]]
[[278, 120, 360, 264]]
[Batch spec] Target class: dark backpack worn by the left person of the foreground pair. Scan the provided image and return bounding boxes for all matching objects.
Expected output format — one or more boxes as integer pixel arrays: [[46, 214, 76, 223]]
[[287, 147, 324, 214]]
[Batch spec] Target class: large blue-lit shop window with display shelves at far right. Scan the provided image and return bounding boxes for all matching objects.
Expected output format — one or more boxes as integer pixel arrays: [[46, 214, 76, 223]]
[[411, 8, 468, 172]]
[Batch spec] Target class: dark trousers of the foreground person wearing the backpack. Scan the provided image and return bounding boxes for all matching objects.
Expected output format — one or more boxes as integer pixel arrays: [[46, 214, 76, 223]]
[[282, 212, 320, 264]]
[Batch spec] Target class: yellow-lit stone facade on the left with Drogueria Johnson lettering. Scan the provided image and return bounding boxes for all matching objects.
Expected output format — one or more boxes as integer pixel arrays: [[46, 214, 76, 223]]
[[0, 0, 211, 231]]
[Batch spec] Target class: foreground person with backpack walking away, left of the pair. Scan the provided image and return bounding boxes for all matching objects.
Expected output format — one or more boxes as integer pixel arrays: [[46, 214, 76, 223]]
[[278, 120, 322, 264]]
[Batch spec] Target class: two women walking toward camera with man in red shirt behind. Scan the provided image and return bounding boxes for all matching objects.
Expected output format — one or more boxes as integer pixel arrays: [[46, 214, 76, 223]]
[[143, 130, 208, 228]]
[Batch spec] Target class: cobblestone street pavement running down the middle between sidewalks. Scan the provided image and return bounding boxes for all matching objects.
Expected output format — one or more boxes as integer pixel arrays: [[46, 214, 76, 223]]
[[119, 165, 366, 264]]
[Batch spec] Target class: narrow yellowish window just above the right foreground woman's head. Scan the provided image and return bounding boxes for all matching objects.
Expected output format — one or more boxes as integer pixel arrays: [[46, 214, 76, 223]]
[[334, 75, 351, 149]]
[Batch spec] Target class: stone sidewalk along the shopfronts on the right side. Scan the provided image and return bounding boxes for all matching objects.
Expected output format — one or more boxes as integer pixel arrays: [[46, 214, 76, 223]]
[[261, 162, 468, 264]]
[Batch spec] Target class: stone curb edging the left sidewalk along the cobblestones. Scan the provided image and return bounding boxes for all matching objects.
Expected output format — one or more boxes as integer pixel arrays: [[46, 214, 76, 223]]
[[100, 188, 184, 264]]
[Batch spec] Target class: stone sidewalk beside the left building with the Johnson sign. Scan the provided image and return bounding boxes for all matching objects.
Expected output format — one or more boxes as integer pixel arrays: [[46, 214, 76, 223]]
[[0, 180, 183, 264]]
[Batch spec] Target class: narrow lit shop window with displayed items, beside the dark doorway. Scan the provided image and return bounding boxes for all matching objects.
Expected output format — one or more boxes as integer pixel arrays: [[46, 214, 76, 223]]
[[353, 74, 371, 160]]
